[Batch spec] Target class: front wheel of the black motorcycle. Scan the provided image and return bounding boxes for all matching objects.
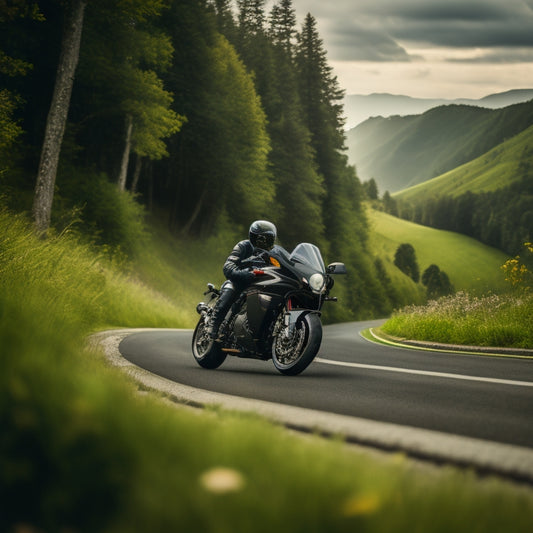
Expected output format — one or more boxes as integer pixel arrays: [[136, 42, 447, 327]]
[[272, 313, 322, 376]]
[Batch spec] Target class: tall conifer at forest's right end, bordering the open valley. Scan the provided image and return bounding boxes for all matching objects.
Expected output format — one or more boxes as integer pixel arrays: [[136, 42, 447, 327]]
[[295, 14, 387, 318]]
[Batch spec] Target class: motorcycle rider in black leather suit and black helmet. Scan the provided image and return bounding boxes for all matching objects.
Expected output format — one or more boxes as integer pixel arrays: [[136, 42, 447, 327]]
[[207, 220, 277, 340]]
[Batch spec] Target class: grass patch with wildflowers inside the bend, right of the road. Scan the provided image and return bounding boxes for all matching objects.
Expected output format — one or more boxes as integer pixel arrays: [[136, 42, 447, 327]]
[[381, 292, 533, 349]]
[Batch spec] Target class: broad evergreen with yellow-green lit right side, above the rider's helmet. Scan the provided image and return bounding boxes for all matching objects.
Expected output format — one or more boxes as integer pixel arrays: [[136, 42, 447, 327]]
[[157, 0, 273, 234]]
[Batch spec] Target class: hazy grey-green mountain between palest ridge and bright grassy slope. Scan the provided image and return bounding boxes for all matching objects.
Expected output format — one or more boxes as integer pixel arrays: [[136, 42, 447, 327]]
[[347, 101, 533, 192]]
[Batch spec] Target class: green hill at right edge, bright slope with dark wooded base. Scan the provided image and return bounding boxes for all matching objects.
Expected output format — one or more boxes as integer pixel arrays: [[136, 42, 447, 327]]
[[391, 119, 533, 255]]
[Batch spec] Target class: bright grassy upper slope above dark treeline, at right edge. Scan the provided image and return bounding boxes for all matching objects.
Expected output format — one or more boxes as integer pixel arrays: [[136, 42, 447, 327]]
[[394, 126, 533, 202]]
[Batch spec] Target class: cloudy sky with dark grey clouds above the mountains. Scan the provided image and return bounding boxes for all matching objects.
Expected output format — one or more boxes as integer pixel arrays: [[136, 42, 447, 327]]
[[284, 0, 533, 98]]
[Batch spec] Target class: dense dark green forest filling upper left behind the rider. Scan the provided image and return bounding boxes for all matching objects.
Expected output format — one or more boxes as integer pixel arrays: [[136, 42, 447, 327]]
[[0, 0, 400, 319]]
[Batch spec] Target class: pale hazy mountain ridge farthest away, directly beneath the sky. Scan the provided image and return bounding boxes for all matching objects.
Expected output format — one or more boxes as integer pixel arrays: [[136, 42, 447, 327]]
[[344, 89, 533, 129]]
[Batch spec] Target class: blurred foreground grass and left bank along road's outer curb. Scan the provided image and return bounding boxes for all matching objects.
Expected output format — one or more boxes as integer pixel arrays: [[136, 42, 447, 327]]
[[0, 212, 533, 533]]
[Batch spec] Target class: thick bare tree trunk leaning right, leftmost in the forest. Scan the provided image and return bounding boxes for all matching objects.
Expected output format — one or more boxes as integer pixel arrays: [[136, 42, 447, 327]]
[[33, 0, 87, 235]]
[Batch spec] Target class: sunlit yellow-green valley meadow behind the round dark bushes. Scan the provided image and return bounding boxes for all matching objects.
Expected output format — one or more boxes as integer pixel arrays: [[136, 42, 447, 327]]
[[369, 210, 508, 294]]
